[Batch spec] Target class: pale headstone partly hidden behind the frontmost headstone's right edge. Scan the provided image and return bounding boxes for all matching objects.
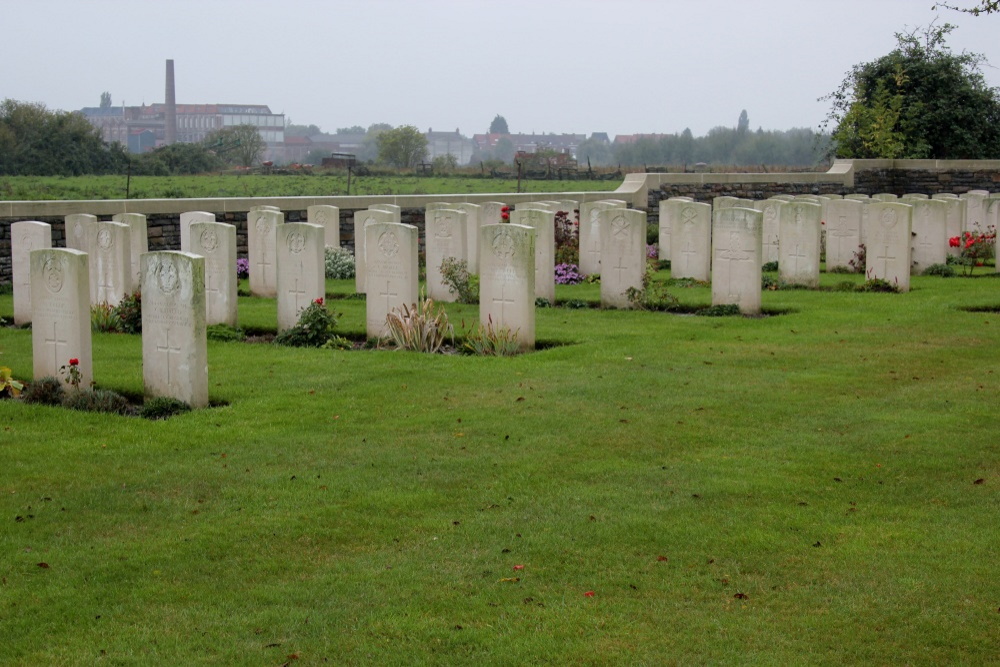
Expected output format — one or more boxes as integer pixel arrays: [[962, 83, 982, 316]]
[[188, 222, 239, 327]]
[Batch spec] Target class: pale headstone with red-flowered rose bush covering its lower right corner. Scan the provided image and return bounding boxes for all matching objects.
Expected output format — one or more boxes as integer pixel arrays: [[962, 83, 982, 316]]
[[277, 222, 326, 332]]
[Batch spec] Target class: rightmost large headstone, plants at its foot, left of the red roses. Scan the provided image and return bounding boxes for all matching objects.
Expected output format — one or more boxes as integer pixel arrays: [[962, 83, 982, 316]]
[[865, 202, 913, 292]]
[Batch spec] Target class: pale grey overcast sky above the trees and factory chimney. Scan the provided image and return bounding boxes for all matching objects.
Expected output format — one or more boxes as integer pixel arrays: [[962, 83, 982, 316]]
[[0, 0, 1000, 137]]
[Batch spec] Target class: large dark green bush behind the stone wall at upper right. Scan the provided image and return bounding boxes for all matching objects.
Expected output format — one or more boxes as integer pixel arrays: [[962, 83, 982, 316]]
[[822, 24, 1000, 160]]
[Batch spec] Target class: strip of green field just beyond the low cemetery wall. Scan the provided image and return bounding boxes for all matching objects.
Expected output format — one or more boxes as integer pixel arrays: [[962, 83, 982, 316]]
[[0, 172, 621, 201]]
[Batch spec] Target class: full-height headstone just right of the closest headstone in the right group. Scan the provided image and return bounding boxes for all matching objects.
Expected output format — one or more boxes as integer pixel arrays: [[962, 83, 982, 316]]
[[778, 200, 823, 287]]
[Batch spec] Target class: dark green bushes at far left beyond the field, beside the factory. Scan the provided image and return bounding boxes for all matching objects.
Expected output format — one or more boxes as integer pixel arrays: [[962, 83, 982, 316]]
[[0, 99, 127, 176]]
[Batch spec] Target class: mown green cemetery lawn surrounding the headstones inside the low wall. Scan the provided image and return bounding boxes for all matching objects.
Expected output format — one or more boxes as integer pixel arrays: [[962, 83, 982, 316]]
[[0, 267, 1000, 665]]
